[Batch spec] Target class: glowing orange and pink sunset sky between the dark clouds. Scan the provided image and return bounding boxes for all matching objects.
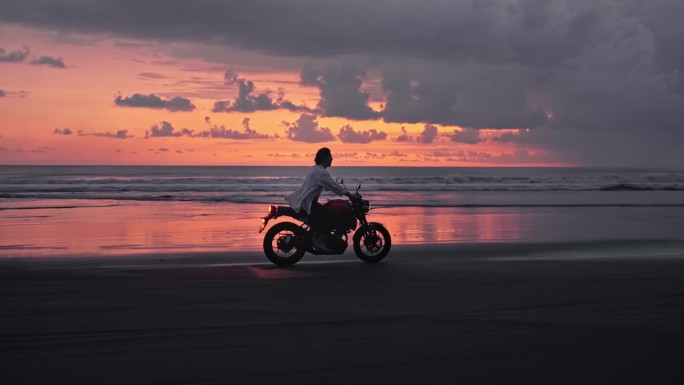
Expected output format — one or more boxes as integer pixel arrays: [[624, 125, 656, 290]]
[[0, 25, 573, 166]]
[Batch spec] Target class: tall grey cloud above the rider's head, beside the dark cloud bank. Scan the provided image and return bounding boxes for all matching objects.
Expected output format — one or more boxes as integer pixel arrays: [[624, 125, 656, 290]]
[[300, 65, 380, 120]]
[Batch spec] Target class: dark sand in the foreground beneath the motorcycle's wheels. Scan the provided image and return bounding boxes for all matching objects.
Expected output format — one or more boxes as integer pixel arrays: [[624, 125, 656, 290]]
[[0, 241, 684, 384]]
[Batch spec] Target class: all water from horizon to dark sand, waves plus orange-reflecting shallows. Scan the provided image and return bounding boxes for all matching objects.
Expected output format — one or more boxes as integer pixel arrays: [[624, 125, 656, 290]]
[[0, 166, 684, 260]]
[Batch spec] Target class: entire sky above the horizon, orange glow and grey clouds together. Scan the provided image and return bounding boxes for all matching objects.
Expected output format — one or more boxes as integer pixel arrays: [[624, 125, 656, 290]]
[[0, 0, 684, 167]]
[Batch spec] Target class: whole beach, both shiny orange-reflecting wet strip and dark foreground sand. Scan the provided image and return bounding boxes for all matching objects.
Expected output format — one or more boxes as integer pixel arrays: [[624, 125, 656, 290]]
[[0, 196, 684, 384]]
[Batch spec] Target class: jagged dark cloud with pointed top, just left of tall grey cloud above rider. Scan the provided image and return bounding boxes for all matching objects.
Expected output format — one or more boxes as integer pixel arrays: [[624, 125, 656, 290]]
[[212, 70, 309, 112]]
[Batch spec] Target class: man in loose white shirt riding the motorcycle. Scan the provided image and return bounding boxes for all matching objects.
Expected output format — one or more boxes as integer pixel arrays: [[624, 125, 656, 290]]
[[285, 147, 352, 251]]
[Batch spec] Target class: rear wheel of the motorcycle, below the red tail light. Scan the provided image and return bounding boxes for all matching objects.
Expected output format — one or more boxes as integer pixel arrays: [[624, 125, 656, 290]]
[[264, 222, 306, 266]]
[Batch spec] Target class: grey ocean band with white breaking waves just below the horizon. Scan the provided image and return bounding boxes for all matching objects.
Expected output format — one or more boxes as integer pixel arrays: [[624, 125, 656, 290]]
[[0, 166, 684, 208]]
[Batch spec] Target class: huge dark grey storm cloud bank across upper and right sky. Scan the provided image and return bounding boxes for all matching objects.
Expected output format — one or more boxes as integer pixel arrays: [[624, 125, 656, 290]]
[[0, 0, 684, 165]]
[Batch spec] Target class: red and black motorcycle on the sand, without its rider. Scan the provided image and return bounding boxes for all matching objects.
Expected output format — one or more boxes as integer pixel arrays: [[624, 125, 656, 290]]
[[259, 178, 392, 266]]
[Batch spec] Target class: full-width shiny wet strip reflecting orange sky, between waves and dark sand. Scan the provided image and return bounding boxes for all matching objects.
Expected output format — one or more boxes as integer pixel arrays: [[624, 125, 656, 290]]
[[0, 201, 681, 257]]
